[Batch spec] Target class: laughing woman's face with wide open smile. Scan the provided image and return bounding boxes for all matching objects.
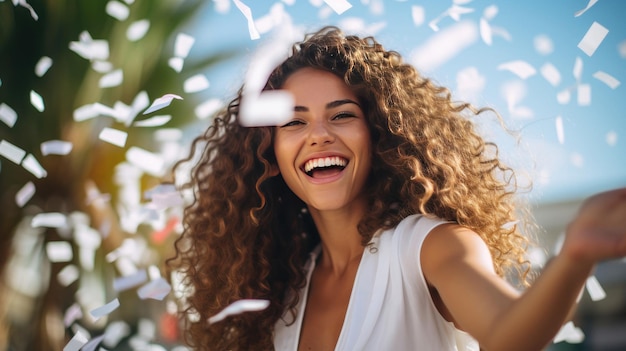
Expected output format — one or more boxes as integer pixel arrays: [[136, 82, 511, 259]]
[[274, 68, 371, 211]]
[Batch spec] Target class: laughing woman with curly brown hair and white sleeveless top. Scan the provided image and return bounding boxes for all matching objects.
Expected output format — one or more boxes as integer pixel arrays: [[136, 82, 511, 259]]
[[169, 28, 626, 350]]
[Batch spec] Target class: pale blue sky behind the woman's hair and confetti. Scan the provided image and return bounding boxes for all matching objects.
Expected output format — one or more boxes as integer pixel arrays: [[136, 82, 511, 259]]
[[180, 0, 626, 202]]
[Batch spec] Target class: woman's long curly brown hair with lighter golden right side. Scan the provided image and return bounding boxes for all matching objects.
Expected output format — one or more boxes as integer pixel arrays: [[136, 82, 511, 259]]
[[169, 27, 530, 350]]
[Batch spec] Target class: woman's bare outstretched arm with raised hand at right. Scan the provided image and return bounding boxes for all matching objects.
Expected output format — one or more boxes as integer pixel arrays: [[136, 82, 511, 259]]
[[422, 188, 626, 351]]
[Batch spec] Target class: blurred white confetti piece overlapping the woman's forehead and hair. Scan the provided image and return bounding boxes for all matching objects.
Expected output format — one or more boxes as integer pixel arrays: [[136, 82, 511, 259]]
[[239, 90, 295, 127]]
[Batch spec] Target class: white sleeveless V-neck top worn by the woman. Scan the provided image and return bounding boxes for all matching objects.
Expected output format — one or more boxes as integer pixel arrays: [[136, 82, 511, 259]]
[[274, 215, 479, 351]]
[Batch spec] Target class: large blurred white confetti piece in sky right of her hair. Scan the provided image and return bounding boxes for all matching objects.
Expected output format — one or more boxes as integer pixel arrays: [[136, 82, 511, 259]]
[[410, 21, 480, 72]]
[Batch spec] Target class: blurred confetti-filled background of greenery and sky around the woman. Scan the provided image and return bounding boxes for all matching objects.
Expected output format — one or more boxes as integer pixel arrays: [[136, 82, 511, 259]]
[[0, 0, 626, 350]]
